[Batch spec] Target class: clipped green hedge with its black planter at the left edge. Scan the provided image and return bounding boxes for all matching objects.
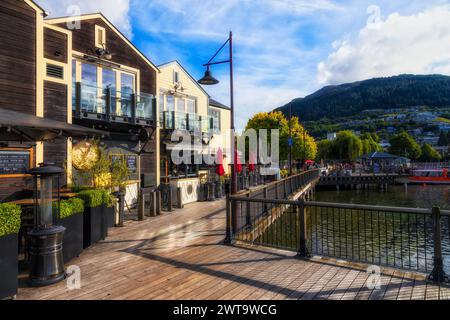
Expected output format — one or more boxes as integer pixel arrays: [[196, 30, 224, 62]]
[[0, 203, 21, 299]]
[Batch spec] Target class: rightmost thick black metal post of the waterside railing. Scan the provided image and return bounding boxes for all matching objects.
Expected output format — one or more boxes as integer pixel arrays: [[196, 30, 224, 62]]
[[429, 207, 448, 283]]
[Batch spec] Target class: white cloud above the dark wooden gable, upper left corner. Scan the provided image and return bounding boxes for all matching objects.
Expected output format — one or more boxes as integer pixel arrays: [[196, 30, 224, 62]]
[[36, 0, 133, 38]]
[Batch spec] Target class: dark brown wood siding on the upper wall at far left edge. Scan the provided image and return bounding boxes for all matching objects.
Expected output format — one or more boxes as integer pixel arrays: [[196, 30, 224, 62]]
[[0, 0, 36, 114]]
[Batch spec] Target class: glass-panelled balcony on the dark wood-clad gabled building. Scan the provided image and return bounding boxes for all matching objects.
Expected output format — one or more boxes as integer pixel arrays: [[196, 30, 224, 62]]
[[73, 82, 156, 126]]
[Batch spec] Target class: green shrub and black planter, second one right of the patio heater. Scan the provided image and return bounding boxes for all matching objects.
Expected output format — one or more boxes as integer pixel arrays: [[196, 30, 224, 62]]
[[78, 189, 106, 248]]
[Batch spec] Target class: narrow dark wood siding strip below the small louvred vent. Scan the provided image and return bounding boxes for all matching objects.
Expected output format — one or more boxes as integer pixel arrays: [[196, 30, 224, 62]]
[[44, 81, 67, 184]]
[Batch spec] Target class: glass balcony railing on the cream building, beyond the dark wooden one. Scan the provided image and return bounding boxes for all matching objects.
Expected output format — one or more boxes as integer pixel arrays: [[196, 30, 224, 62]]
[[160, 111, 213, 132]]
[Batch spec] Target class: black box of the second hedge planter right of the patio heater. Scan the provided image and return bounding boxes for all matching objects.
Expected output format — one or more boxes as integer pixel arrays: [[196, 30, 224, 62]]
[[83, 206, 106, 248]]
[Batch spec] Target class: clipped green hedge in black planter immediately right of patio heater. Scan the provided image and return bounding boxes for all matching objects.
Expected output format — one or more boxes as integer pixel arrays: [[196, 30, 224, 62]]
[[60, 198, 84, 262]]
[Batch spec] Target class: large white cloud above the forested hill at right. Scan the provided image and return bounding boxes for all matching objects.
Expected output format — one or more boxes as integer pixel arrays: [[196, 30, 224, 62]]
[[317, 5, 450, 84]]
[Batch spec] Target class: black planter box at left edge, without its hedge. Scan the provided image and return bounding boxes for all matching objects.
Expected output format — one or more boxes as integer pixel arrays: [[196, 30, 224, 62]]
[[0, 234, 18, 299]]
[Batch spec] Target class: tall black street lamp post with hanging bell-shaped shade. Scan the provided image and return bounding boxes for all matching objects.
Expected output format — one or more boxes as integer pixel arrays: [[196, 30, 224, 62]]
[[198, 31, 237, 242]]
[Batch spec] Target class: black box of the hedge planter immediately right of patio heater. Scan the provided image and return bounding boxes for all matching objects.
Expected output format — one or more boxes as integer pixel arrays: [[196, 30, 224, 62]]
[[60, 214, 83, 263]]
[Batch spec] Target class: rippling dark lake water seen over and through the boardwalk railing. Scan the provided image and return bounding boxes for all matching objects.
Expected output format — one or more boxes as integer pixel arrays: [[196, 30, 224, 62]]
[[256, 186, 450, 274]]
